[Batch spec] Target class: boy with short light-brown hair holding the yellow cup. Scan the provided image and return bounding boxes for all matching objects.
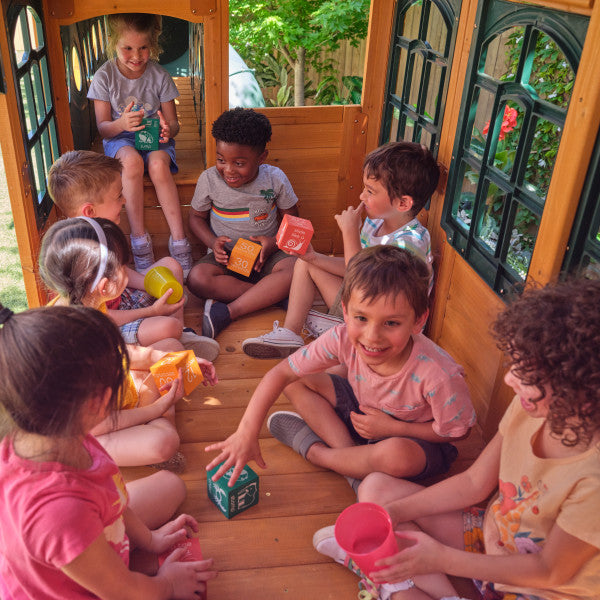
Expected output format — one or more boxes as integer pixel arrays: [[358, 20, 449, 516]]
[[48, 150, 220, 361]]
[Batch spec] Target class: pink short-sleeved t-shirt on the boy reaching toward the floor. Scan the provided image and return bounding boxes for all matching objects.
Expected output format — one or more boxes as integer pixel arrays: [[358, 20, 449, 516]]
[[288, 325, 476, 437]]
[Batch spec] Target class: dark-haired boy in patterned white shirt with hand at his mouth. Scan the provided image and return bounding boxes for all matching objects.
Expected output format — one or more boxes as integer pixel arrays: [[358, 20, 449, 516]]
[[242, 141, 440, 358]]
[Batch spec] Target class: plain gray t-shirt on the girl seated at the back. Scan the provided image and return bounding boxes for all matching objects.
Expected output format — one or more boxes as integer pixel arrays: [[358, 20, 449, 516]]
[[88, 58, 179, 121]]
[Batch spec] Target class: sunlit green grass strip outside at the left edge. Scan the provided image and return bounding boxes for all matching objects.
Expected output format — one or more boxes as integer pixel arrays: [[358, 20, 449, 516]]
[[0, 147, 27, 312]]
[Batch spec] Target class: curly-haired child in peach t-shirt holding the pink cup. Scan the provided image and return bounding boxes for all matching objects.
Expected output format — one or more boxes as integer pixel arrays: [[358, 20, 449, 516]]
[[313, 279, 600, 600]]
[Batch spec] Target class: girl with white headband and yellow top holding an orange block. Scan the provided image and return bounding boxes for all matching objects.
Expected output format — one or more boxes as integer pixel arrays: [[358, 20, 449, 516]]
[[39, 217, 217, 470]]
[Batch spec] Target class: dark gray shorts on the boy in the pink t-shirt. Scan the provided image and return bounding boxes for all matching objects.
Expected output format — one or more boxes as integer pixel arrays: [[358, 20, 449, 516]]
[[329, 374, 458, 481]]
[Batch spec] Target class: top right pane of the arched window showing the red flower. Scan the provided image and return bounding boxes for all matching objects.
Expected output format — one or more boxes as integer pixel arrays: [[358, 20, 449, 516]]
[[527, 33, 575, 108]]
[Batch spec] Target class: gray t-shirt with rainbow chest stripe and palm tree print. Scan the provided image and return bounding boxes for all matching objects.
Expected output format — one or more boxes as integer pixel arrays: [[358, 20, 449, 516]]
[[192, 165, 298, 243]]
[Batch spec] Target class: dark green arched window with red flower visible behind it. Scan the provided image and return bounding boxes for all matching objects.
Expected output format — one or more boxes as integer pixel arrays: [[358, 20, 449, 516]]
[[442, 0, 588, 295]]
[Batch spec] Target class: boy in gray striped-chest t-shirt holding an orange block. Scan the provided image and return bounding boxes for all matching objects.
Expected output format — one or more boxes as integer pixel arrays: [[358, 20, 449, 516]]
[[187, 108, 298, 338]]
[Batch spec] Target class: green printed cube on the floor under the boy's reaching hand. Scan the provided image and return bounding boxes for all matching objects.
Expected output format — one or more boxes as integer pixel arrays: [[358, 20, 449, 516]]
[[206, 463, 258, 519]]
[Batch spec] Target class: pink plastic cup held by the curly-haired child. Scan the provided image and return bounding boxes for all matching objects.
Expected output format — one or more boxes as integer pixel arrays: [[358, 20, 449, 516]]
[[334, 502, 398, 575]]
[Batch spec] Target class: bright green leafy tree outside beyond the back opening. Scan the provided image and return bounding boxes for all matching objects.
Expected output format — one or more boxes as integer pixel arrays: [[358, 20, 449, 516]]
[[229, 0, 370, 106]]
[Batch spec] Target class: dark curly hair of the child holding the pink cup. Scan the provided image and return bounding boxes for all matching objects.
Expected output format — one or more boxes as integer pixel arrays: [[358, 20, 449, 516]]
[[493, 279, 600, 446]]
